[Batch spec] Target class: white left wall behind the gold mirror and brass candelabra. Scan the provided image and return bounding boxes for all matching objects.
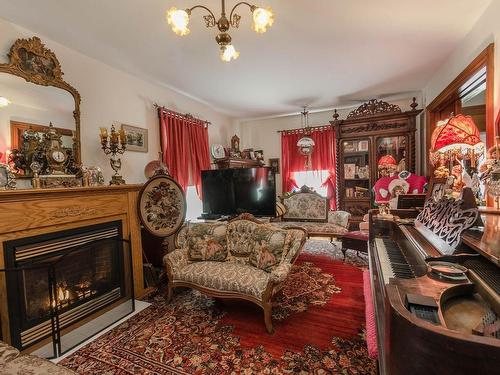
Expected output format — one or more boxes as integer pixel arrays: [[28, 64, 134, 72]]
[[0, 19, 232, 183]]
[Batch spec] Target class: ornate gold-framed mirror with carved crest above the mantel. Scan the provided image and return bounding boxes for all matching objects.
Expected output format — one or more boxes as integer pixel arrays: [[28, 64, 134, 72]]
[[0, 36, 81, 175]]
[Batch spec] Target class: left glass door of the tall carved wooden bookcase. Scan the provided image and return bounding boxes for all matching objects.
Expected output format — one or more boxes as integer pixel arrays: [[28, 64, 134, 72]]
[[342, 138, 370, 199]]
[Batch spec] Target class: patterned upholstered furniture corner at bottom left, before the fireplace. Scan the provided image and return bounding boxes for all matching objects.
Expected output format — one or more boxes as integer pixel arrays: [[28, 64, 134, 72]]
[[0, 341, 76, 375]]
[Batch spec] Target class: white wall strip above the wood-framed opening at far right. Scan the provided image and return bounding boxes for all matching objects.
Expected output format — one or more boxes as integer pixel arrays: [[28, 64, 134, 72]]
[[424, 0, 500, 134]]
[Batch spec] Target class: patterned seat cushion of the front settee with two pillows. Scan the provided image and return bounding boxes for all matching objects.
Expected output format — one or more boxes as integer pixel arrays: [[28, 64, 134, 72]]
[[175, 261, 271, 300]]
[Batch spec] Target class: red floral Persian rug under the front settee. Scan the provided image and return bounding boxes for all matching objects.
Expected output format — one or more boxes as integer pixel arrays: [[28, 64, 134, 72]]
[[60, 253, 376, 375]]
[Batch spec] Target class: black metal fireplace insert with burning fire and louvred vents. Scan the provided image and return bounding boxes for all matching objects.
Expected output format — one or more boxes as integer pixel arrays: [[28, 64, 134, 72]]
[[4, 221, 130, 349]]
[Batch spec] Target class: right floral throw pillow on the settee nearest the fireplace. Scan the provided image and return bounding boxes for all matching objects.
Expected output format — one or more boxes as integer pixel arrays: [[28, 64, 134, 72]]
[[248, 225, 289, 272]]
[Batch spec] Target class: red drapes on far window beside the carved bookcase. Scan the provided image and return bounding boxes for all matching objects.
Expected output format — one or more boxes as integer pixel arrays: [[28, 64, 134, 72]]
[[281, 128, 336, 209]]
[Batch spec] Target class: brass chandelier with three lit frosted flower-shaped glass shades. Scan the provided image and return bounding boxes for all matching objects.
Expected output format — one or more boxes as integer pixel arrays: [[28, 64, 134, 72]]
[[167, 0, 274, 62]]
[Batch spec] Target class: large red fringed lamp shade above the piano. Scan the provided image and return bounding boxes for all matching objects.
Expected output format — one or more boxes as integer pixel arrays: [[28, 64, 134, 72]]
[[431, 115, 484, 166]]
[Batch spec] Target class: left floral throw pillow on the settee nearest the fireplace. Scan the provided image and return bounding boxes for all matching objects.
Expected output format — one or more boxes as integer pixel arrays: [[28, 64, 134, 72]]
[[186, 223, 227, 262]]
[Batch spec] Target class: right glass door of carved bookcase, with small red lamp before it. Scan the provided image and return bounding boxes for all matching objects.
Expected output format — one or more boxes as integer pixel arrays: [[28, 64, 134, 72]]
[[376, 136, 408, 178]]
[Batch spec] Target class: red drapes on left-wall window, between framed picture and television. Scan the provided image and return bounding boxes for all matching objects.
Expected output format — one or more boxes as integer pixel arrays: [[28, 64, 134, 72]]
[[158, 108, 210, 196]]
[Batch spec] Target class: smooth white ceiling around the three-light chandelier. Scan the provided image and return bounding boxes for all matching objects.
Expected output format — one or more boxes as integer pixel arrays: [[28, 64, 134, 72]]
[[0, 0, 491, 118]]
